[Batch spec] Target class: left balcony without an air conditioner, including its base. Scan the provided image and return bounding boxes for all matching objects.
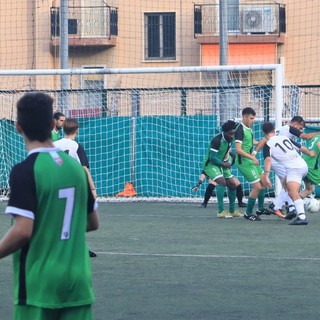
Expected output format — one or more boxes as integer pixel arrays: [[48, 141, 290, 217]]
[[50, 6, 118, 49]]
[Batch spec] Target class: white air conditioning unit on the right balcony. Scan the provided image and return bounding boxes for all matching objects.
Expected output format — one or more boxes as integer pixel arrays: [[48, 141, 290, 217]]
[[242, 7, 278, 33]]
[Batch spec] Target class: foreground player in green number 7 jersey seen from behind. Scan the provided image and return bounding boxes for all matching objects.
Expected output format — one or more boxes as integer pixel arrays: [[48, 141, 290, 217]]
[[0, 92, 99, 320]]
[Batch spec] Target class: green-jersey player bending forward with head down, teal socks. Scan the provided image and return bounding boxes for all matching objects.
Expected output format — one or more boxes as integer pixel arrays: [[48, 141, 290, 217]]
[[203, 120, 241, 218]]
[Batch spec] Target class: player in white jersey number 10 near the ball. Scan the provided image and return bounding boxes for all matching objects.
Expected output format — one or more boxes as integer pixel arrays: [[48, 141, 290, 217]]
[[262, 122, 308, 225]]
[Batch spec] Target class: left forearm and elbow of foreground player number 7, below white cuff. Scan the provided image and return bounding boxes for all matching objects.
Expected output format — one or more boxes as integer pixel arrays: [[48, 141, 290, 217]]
[[0, 215, 33, 259]]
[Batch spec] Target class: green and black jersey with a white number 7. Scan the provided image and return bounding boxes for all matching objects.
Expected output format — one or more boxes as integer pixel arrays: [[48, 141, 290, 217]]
[[6, 148, 95, 308]]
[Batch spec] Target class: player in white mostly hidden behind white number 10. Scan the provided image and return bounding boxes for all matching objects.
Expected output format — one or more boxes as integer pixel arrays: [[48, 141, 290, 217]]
[[255, 116, 319, 219]]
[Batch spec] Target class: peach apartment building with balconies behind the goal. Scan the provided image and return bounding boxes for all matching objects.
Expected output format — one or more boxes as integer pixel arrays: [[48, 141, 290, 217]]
[[0, 0, 320, 118]]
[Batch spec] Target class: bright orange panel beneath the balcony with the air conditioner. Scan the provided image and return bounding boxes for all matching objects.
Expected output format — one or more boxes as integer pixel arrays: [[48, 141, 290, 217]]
[[201, 43, 277, 66]]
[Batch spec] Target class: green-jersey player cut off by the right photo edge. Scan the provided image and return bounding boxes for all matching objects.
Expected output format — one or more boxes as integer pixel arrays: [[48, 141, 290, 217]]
[[300, 134, 320, 198]]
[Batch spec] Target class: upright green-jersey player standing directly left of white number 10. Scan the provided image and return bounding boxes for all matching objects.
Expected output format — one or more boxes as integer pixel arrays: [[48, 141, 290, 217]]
[[235, 107, 271, 221]]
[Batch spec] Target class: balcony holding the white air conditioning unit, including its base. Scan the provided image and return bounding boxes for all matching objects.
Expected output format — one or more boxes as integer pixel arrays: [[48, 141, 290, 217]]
[[194, 3, 286, 44]]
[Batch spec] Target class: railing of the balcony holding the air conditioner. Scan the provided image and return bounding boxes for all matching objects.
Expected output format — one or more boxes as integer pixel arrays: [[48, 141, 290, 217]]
[[194, 3, 286, 37]]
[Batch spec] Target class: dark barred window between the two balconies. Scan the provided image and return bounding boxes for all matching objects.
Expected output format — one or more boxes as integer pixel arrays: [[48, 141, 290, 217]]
[[145, 13, 176, 60]]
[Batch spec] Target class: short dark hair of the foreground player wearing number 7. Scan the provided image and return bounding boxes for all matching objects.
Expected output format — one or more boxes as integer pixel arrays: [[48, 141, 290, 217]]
[[17, 92, 53, 142]]
